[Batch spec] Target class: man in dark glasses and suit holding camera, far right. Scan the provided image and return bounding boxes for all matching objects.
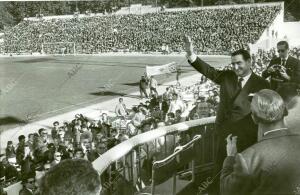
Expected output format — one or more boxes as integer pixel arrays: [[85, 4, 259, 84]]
[[262, 41, 300, 90]]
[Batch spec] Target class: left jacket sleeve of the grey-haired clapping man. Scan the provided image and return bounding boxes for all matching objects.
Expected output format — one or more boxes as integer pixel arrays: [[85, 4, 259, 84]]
[[220, 154, 253, 195]]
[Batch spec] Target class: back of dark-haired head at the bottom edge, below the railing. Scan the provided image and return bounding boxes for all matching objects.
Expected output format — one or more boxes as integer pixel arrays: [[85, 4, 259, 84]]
[[39, 159, 101, 195]]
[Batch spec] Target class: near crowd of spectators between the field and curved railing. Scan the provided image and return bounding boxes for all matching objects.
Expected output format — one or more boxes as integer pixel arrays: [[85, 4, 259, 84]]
[[0, 74, 218, 193]]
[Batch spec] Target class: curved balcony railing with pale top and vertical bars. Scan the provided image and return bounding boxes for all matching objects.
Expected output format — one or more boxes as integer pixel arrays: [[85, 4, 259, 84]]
[[93, 117, 215, 194]]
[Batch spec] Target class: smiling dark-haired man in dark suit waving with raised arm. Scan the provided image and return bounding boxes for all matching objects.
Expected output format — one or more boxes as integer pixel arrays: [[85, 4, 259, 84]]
[[184, 36, 269, 194]]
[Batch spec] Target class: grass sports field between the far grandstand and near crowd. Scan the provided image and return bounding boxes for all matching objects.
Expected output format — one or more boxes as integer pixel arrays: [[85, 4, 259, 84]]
[[0, 56, 228, 130]]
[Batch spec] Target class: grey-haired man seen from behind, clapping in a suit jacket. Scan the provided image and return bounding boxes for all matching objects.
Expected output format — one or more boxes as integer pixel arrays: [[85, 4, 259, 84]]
[[221, 89, 300, 195]]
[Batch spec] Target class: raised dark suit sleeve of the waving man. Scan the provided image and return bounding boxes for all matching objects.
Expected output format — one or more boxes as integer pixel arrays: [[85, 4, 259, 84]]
[[190, 57, 224, 84]]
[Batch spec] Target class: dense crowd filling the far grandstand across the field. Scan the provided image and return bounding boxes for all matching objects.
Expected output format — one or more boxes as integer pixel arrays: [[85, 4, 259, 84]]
[[4, 6, 280, 54]]
